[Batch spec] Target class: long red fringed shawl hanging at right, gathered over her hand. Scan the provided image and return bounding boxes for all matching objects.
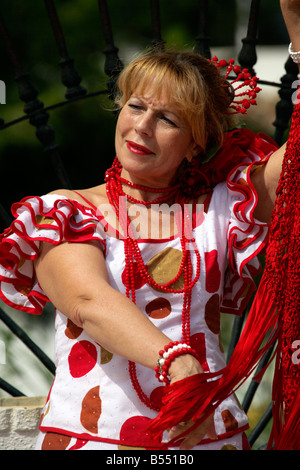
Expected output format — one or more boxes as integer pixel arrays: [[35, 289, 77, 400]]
[[149, 104, 300, 450]]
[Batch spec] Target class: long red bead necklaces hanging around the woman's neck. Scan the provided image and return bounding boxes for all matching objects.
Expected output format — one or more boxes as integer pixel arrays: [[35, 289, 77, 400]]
[[105, 158, 200, 411]]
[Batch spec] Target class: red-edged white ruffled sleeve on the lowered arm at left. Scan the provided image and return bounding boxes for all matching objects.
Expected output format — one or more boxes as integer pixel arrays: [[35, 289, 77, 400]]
[[0, 194, 105, 314]]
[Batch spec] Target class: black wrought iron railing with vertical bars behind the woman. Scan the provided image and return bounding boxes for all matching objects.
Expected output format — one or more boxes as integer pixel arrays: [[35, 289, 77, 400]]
[[0, 0, 297, 445]]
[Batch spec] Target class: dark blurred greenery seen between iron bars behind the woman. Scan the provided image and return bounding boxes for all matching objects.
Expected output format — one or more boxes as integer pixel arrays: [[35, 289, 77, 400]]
[[0, 0, 287, 216]]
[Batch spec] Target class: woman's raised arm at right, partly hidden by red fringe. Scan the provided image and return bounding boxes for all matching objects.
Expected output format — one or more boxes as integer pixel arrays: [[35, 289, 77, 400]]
[[252, 0, 300, 223]]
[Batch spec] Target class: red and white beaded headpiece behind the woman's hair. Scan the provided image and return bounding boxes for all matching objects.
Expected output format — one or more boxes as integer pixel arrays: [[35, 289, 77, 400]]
[[211, 56, 261, 114]]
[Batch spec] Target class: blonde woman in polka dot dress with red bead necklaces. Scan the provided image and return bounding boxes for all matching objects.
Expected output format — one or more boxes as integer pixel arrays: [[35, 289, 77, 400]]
[[0, 2, 300, 450]]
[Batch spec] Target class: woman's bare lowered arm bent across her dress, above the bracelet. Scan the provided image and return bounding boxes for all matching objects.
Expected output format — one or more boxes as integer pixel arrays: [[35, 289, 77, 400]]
[[35, 242, 193, 369]]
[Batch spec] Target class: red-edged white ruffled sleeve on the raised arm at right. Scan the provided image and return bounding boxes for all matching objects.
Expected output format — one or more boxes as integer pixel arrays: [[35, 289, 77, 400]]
[[222, 134, 278, 315]]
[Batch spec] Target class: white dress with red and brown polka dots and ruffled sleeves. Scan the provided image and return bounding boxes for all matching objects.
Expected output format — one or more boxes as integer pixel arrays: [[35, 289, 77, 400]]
[[0, 149, 268, 449]]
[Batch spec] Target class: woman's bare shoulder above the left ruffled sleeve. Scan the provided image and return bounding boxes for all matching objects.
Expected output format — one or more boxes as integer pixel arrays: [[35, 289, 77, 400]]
[[48, 184, 108, 207]]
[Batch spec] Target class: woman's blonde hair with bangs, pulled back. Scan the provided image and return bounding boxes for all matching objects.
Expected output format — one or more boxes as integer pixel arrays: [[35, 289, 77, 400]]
[[116, 51, 233, 153]]
